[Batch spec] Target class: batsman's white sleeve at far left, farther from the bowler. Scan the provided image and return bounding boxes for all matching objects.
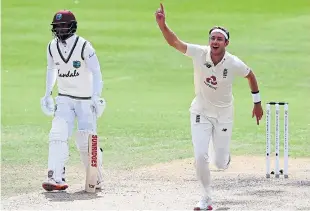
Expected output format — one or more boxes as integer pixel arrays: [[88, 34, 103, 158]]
[[45, 43, 57, 96]]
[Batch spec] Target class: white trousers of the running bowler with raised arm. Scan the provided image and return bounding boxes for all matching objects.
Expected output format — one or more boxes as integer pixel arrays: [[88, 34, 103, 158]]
[[190, 113, 233, 199]]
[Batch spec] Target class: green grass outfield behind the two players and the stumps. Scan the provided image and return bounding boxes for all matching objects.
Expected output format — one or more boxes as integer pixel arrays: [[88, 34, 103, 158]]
[[1, 0, 310, 195]]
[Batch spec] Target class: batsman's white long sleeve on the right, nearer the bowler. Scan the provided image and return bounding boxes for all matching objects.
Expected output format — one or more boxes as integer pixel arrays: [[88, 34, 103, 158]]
[[84, 42, 103, 97]]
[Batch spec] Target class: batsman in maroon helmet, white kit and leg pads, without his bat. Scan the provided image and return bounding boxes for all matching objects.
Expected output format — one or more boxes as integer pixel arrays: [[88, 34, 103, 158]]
[[41, 10, 105, 191]]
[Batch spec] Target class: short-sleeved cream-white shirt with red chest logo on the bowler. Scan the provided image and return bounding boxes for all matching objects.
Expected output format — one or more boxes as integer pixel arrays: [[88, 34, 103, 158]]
[[185, 44, 250, 117]]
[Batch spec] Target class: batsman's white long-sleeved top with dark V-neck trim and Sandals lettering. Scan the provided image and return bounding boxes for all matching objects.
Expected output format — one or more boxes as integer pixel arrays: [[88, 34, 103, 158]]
[[46, 35, 103, 97]]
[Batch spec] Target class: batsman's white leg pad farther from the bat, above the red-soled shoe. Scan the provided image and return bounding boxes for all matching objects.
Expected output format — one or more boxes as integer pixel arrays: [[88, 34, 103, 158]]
[[48, 117, 69, 182]]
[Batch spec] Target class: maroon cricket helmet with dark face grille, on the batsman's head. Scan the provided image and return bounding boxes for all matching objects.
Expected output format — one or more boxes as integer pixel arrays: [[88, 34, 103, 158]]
[[51, 10, 77, 42]]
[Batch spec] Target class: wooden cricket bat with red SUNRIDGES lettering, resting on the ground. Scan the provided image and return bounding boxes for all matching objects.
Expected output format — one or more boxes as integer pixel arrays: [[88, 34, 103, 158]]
[[85, 134, 99, 193]]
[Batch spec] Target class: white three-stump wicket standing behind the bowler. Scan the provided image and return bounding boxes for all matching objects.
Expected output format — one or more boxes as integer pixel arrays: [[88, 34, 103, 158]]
[[266, 102, 288, 178]]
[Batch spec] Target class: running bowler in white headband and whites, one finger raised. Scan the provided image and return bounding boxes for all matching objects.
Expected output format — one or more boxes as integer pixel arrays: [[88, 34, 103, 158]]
[[155, 4, 263, 210]]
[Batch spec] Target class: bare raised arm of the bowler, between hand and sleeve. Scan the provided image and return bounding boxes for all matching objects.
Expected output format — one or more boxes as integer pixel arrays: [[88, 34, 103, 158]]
[[159, 23, 187, 54]]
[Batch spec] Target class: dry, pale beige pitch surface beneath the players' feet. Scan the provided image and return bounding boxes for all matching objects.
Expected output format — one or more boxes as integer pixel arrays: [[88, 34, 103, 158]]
[[1, 156, 310, 210]]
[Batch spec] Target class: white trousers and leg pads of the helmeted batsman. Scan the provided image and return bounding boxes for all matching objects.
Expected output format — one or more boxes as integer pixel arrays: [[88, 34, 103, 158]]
[[48, 96, 97, 181]]
